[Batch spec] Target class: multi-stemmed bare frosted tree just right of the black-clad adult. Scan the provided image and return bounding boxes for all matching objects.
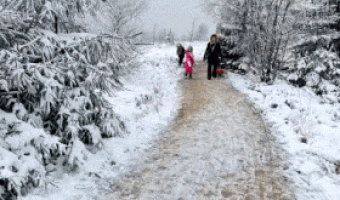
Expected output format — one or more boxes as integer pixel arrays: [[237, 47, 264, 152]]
[[206, 0, 292, 81]]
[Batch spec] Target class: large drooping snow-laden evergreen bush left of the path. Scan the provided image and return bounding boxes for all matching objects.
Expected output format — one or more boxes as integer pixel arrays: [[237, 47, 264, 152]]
[[0, 15, 138, 199]]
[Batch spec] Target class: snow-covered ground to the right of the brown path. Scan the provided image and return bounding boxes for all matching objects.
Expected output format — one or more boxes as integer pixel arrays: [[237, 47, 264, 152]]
[[228, 73, 340, 200]]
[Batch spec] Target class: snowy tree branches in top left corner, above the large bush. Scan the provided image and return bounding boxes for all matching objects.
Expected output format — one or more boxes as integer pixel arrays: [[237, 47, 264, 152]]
[[0, 0, 101, 40]]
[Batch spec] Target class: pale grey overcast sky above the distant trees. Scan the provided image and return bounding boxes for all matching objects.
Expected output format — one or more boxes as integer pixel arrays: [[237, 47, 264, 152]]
[[141, 0, 216, 37]]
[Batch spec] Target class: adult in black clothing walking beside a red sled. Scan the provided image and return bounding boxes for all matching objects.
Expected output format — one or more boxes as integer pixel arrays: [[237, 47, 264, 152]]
[[203, 34, 221, 80]]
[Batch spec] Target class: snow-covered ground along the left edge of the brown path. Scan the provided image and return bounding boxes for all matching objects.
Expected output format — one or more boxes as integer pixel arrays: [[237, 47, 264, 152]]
[[23, 42, 206, 200]]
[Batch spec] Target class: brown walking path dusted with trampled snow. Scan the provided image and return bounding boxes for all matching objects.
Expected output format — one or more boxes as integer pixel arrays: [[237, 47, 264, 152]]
[[107, 63, 295, 200]]
